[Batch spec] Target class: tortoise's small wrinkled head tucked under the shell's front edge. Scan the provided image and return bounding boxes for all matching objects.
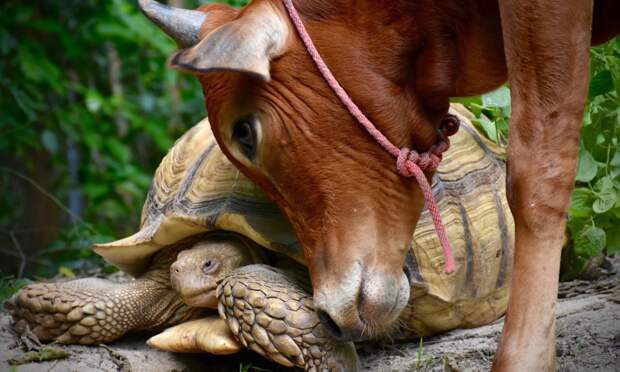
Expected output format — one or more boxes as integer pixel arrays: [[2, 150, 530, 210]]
[[170, 234, 256, 309]]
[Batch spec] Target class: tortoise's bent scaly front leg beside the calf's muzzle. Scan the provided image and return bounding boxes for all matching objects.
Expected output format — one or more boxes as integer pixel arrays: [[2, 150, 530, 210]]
[[217, 265, 359, 371]]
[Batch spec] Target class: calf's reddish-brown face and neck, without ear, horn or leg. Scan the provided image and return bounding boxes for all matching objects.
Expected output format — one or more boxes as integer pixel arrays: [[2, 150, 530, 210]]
[[188, 1, 505, 339]]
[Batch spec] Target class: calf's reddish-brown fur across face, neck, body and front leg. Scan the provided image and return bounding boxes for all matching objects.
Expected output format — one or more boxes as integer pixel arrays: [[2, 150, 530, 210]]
[[171, 0, 620, 370]]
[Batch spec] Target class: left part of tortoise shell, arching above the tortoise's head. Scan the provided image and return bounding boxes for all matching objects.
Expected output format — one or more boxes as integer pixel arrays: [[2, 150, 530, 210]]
[[94, 119, 303, 276]]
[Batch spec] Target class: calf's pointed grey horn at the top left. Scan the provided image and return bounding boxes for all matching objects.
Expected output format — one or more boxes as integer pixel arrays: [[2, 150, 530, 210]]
[[138, 0, 207, 48]]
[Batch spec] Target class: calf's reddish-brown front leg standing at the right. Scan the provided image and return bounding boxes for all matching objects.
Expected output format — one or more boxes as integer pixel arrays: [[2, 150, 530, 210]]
[[493, 0, 592, 371]]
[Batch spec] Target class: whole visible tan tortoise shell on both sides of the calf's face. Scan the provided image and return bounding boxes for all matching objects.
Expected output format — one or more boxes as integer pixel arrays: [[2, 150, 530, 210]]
[[94, 105, 514, 335]]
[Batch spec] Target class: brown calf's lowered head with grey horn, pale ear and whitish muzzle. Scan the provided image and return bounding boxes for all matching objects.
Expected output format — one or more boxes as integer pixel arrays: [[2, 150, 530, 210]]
[[141, 0, 448, 340]]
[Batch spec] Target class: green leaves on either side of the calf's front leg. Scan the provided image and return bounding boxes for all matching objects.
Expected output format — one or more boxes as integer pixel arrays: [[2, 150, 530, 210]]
[[456, 38, 620, 279]]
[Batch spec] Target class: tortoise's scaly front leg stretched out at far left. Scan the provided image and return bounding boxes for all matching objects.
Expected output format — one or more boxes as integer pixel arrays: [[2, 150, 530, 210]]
[[5, 277, 201, 345]]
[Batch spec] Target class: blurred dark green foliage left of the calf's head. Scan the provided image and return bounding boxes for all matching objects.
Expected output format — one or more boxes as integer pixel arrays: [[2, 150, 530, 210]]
[[0, 0, 245, 275]]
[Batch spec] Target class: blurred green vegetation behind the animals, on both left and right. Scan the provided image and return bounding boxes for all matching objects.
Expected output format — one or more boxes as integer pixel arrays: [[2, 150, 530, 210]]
[[0, 0, 620, 296]]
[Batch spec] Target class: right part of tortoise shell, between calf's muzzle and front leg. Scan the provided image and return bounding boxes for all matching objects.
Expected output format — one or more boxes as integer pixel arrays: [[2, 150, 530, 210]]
[[400, 105, 514, 339]]
